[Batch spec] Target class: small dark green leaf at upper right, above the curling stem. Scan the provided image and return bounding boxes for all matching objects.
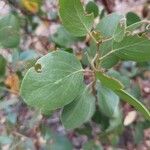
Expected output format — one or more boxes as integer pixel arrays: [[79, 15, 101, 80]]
[[126, 12, 141, 26]]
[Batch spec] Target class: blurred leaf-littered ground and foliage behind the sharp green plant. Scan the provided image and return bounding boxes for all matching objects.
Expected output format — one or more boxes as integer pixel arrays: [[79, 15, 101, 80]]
[[0, 0, 150, 150]]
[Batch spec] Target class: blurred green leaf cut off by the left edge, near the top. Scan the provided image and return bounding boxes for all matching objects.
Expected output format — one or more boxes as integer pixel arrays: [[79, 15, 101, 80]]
[[0, 14, 20, 48]]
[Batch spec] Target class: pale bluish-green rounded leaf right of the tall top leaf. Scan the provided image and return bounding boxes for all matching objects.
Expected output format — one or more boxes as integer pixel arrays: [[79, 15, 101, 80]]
[[96, 13, 123, 37]]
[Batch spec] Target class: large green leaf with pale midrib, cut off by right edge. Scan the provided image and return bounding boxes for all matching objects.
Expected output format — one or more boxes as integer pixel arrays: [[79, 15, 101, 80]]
[[112, 36, 150, 62]]
